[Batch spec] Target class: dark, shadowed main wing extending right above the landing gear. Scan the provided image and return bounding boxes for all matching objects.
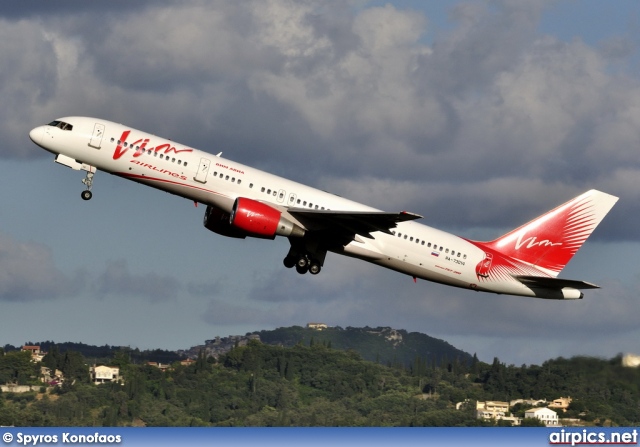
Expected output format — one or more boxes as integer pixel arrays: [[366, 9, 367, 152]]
[[287, 208, 422, 240]]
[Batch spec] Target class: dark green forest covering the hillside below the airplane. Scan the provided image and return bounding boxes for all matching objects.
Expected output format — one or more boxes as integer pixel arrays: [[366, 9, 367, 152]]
[[0, 341, 640, 427]]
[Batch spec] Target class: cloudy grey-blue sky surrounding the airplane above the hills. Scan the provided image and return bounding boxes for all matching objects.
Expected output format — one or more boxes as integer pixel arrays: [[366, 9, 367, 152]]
[[0, 0, 640, 365]]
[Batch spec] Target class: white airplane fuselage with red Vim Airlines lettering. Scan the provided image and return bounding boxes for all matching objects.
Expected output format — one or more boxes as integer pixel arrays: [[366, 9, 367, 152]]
[[30, 117, 564, 296]]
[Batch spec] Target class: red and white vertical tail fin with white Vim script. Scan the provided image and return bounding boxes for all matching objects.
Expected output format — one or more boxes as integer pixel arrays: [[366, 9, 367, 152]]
[[483, 189, 618, 277]]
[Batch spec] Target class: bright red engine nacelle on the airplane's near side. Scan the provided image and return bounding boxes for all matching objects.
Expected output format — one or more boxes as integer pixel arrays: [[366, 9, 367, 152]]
[[229, 197, 304, 239]]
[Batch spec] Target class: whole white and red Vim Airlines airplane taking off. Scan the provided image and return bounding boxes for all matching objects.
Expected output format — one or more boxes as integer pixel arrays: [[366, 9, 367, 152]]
[[29, 116, 618, 300]]
